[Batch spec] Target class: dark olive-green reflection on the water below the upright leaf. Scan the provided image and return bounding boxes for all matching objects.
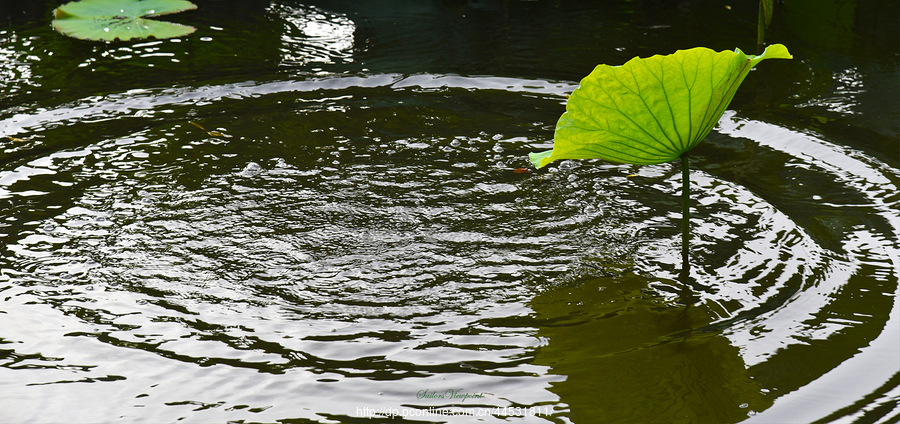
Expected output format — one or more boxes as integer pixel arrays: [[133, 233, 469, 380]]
[[531, 275, 771, 423]]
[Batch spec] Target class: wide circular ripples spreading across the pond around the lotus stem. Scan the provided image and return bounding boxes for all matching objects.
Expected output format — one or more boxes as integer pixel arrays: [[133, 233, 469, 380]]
[[0, 74, 900, 422]]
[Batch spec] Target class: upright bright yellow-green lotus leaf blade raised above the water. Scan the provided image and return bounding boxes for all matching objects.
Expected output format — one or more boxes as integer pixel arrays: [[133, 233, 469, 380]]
[[529, 44, 791, 168]]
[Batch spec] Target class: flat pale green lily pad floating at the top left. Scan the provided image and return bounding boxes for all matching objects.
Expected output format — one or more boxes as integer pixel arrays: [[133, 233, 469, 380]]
[[52, 0, 197, 41]]
